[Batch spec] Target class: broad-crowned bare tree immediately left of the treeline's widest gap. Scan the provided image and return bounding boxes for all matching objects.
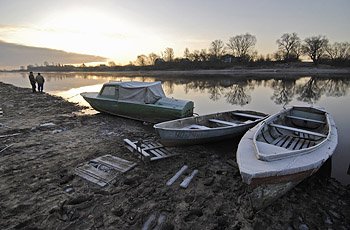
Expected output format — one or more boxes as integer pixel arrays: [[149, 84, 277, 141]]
[[226, 33, 256, 58]]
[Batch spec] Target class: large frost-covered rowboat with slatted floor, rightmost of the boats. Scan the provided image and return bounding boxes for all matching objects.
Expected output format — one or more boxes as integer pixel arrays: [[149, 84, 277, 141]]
[[237, 106, 338, 209]]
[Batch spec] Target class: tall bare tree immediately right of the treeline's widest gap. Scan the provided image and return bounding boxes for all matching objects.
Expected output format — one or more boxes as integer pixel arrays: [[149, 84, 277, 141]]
[[276, 33, 301, 61]]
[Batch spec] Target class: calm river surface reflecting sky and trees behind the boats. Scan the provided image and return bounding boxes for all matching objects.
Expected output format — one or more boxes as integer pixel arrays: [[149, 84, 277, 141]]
[[0, 73, 350, 184]]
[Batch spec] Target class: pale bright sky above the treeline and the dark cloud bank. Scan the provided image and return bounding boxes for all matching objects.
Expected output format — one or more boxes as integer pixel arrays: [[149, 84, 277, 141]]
[[0, 0, 350, 68]]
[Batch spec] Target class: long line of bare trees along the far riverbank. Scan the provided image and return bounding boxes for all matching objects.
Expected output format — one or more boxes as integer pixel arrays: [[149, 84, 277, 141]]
[[131, 33, 350, 66]]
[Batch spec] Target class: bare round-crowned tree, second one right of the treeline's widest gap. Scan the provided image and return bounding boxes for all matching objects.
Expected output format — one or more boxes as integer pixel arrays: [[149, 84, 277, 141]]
[[303, 35, 328, 65]]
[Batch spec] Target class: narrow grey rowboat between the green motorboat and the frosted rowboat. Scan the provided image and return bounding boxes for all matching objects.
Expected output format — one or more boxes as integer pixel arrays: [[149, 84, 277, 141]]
[[154, 110, 268, 146]]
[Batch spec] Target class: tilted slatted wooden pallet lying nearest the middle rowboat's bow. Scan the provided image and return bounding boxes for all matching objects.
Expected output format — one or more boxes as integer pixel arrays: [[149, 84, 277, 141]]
[[124, 139, 178, 162]]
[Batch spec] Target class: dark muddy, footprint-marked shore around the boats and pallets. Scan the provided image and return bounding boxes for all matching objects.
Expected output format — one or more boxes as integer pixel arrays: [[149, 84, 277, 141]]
[[0, 82, 350, 229]]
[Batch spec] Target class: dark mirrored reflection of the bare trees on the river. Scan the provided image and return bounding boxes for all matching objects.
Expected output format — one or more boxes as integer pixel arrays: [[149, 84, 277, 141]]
[[159, 77, 350, 106]]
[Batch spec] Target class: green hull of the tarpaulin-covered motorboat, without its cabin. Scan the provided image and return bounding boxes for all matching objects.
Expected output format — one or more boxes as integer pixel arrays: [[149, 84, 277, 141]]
[[81, 93, 193, 123]]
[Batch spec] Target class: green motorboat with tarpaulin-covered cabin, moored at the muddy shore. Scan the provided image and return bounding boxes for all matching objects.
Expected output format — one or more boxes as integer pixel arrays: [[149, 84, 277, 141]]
[[80, 81, 194, 123]]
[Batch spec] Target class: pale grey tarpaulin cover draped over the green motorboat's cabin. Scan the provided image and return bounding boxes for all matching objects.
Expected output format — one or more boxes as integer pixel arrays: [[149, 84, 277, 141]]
[[118, 81, 165, 104]]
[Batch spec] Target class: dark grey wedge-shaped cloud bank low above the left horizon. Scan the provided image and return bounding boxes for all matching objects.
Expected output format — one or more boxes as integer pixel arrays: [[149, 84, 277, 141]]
[[0, 40, 107, 69]]
